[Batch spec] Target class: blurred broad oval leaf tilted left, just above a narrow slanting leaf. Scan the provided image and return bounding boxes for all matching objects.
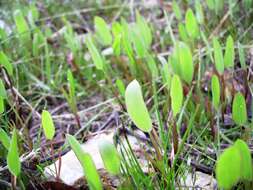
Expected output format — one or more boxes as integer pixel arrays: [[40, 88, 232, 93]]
[[94, 16, 112, 46]]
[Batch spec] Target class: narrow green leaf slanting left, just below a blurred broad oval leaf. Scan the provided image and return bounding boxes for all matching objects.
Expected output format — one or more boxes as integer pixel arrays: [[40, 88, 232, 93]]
[[86, 36, 104, 70]]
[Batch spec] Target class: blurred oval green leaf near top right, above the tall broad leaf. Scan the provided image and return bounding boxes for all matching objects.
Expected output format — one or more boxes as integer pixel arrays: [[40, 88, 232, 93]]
[[185, 9, 199, 38]]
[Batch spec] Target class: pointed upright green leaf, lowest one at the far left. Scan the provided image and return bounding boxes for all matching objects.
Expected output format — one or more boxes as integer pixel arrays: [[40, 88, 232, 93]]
[[7, 129, 21, 176]]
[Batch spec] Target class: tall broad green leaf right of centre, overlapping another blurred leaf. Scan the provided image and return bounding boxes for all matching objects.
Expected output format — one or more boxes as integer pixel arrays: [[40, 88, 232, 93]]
[[179, 42, 194, 84]]
